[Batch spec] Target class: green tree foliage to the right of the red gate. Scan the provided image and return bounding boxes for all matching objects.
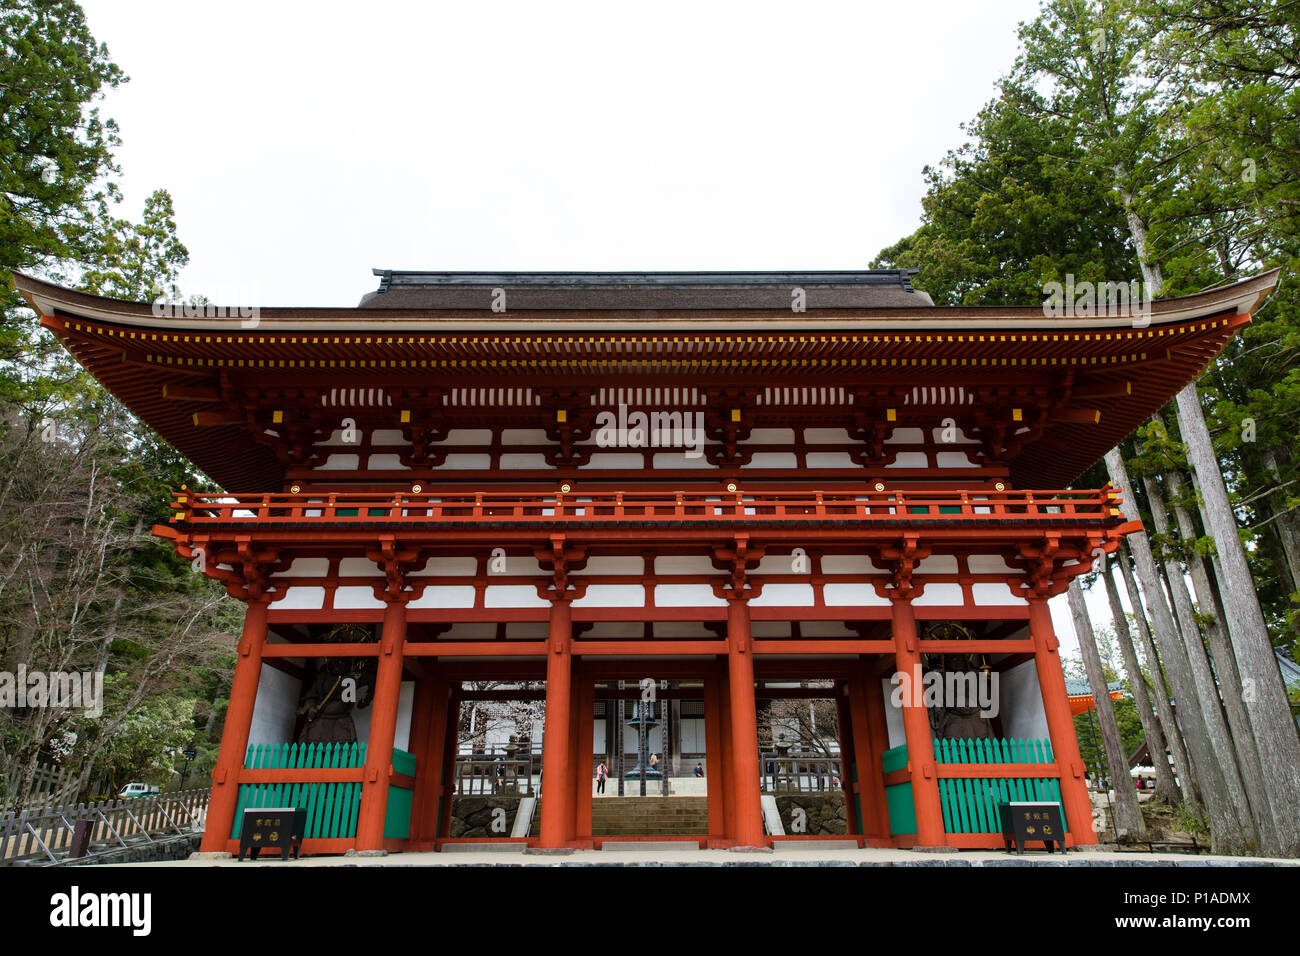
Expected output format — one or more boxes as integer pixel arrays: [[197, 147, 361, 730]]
[[875, 0, 1300, 646]]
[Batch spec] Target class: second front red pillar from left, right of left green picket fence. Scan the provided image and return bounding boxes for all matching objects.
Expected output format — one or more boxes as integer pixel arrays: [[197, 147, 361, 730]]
[[356, 601, 406, 852]]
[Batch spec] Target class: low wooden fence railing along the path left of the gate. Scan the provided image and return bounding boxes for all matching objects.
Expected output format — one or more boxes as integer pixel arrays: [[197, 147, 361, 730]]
[[0, 787, 211, 866]]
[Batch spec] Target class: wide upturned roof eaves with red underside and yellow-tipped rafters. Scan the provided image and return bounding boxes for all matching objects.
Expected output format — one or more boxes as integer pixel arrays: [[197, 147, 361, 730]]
[[16, 271, 1278, 492]]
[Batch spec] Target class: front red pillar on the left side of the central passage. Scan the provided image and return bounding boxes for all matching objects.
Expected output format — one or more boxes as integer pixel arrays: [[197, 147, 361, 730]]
[[537, 601, 573, 849]]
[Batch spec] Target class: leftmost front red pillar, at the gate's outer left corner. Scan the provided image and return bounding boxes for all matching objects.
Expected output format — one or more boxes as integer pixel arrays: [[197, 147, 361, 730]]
[[199, 600, 267, 853]]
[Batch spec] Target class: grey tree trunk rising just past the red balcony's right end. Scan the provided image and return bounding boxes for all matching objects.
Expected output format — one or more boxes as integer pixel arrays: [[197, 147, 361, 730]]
[[1106, 449, 1245, 853]]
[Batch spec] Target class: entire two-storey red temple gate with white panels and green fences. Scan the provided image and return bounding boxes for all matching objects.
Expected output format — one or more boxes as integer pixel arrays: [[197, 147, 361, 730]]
[[18, 272, 1273, 853]]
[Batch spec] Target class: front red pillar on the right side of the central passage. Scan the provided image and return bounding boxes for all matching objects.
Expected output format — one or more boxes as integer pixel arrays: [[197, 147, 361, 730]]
[[727, 600, 768, 847]]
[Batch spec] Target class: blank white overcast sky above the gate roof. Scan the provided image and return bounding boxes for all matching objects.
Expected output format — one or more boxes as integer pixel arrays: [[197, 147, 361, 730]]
[[73, 0, 1109, 671]]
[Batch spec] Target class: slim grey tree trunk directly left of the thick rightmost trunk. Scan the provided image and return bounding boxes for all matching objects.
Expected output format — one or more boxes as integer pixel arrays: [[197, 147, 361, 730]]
[[1165, 472, 1282, 856]]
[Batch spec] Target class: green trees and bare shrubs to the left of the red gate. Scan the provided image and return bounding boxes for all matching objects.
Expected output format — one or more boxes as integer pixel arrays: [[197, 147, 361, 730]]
[[0, 0, 238, 803]]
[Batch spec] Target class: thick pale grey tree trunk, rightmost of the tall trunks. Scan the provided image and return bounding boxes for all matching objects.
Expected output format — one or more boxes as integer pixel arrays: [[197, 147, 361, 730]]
[[1178, 382, 1300, 856]]
